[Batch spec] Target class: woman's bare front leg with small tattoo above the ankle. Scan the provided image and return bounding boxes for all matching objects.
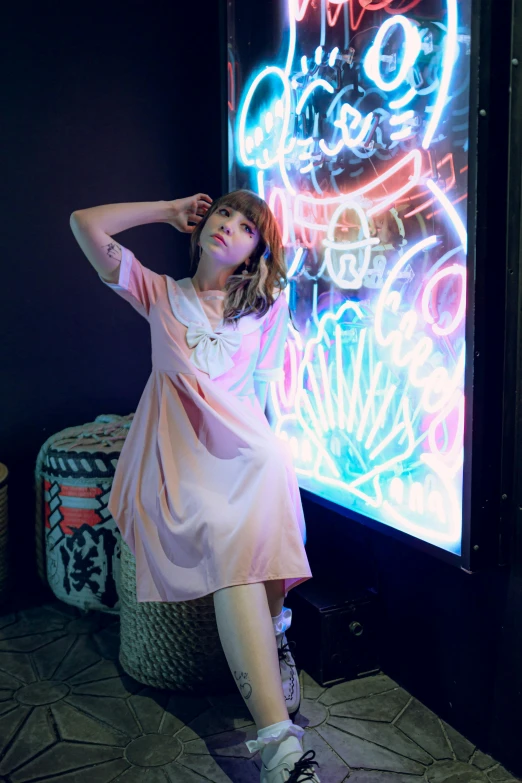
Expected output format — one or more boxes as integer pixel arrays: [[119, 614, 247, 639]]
[[214, 582, 288, 729]]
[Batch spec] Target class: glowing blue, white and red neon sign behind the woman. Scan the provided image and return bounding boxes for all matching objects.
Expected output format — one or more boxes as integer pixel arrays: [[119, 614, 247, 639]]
[[229, 0, 471, 554]]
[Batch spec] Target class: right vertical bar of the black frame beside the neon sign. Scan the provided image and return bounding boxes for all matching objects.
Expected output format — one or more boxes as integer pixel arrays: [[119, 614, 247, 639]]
[[462, 0, 509, 571]]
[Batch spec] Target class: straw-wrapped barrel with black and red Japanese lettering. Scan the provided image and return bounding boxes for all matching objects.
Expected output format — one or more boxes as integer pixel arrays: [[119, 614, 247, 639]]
[[35, 414, 134, 613]]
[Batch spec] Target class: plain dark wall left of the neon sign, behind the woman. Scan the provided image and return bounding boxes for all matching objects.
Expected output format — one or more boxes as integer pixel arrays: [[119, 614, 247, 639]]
[[0, 0, 221, 591]]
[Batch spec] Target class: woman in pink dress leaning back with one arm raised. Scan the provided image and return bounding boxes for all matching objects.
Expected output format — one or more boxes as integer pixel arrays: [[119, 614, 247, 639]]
[[71, 190, 318, 783]]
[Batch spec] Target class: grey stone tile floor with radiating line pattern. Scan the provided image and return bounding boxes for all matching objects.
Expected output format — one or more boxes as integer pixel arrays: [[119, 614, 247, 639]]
[[0, 603, 515, 783]]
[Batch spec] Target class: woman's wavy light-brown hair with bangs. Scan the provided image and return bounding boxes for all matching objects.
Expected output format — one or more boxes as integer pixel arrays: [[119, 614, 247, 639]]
[[190, 190, 288, 323]]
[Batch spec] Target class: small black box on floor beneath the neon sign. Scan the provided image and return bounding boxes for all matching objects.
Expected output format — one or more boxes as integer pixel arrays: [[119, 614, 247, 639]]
[[285, 579, 379, 686]]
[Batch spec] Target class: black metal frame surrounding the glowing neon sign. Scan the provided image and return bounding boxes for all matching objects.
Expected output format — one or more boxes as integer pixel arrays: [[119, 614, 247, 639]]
[[221, 0, 510, 571]]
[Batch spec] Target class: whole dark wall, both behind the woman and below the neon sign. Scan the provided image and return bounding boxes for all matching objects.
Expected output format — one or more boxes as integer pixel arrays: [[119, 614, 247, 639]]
[[0, 0, 522, 772]]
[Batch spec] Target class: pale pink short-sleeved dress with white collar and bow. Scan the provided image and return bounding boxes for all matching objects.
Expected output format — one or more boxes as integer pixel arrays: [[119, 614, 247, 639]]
[[100, 248, 312, 601]]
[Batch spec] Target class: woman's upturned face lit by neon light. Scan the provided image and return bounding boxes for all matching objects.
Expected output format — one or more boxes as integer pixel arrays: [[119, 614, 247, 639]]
[[199, 205, 260, 267]]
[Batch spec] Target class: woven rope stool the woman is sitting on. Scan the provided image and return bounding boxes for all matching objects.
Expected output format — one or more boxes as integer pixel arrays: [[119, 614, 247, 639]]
[[120, 541, 237, 695]]
